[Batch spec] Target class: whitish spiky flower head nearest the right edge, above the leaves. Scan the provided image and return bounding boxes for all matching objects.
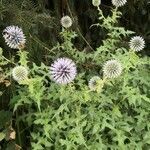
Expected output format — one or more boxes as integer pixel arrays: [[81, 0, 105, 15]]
[[129, 36, 145, 52]]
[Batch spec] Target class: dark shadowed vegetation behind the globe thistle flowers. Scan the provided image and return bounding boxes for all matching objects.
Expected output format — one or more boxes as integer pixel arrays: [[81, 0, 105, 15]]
[[0, 0, 150, 149]]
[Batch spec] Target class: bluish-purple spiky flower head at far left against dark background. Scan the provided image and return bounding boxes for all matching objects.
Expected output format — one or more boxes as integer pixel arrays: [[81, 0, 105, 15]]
[[3, 26, 26, 49]]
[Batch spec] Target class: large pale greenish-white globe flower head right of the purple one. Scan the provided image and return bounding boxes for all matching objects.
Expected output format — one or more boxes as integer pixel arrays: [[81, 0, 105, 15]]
[[103, 60, 122, 78]]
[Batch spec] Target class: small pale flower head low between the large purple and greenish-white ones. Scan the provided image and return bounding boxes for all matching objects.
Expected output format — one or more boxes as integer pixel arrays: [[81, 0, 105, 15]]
[[88, 76, 100, 91]]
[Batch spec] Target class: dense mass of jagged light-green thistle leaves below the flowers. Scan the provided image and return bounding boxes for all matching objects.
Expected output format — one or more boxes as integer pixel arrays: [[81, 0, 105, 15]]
[[0, 0, 150, 150]]
